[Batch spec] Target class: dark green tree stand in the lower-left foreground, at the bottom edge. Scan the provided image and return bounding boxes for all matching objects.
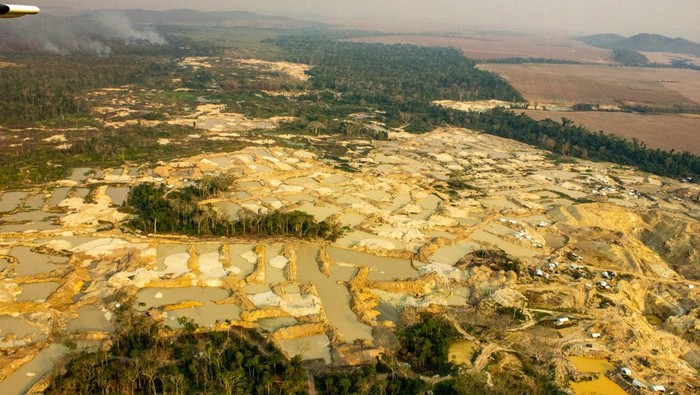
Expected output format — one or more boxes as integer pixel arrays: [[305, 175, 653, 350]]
[[45, 302, 308, 395]]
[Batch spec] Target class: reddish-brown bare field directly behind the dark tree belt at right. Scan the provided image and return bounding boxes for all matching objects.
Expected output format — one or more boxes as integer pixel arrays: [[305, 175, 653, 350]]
[[522, 110, 700, 155]]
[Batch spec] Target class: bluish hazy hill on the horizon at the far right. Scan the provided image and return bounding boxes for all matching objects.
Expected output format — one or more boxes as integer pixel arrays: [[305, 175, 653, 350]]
[[579, 33, 700, 56]]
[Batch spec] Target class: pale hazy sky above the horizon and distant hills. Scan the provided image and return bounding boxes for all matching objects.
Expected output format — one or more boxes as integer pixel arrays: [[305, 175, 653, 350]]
[[27, 0, 700, 41]]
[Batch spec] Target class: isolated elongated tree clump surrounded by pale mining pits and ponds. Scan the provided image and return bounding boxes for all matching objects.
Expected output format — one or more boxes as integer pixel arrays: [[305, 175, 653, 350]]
[[125, 180, 346, 241]]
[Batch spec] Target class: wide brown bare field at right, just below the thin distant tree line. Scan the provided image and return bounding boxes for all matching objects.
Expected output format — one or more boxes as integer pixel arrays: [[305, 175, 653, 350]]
[[479, 64, 700, 110]]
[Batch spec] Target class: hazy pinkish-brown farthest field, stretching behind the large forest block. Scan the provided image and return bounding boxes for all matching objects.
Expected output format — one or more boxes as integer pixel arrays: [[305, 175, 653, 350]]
[[354, 33, 610, 63]]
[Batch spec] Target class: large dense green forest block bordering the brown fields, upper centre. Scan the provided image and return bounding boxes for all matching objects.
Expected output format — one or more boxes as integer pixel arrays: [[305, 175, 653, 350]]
[[273, 36, 523, 132]]
